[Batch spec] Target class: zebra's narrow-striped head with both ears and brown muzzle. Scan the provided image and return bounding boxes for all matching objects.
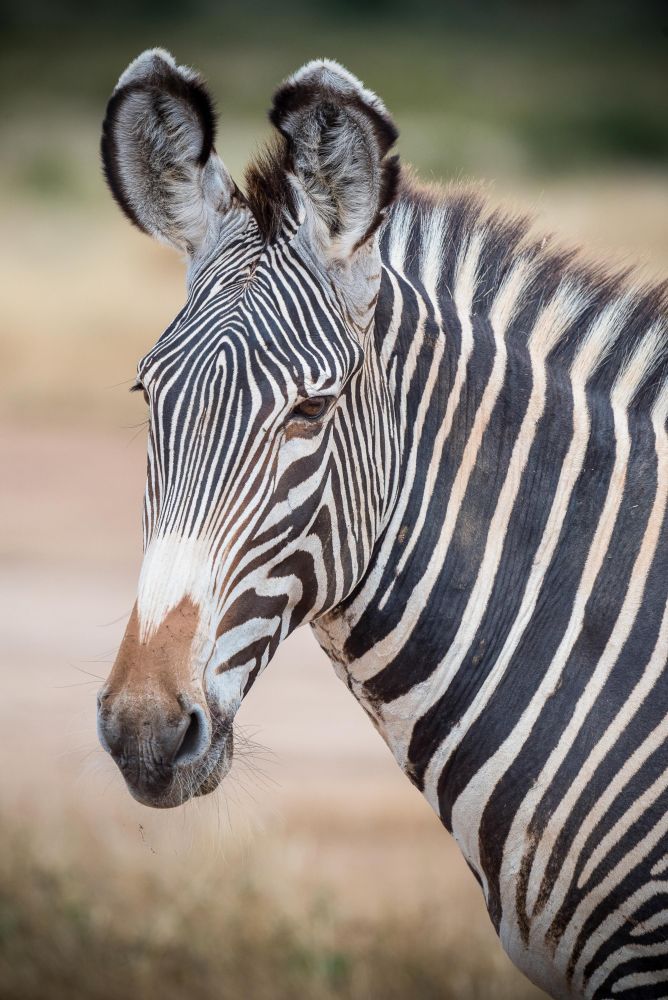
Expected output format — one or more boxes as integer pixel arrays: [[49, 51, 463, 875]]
[[98, 49, 398, 806]]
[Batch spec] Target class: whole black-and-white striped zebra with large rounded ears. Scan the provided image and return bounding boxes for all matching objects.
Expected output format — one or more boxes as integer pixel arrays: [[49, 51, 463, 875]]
[[98, 49, 668, 1000]]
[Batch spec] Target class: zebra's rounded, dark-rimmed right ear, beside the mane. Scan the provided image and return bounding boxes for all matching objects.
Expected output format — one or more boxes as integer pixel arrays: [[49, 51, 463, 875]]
[[269, 59, 399, 262]]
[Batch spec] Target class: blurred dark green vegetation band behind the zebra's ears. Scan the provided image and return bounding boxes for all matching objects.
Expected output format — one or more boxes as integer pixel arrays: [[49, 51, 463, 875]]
[[0, 0, 668, 209]]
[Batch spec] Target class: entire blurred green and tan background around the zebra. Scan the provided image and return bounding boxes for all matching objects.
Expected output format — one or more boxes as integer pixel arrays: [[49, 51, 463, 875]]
[[0, 0, 668, 1000]]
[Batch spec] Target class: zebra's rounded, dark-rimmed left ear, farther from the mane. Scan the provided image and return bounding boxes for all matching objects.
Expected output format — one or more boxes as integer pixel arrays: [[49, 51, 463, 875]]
[[101, 49, 237, 254]]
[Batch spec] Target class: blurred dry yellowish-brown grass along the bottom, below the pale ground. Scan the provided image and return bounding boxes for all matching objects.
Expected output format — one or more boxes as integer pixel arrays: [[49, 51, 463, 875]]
[[0, 824, 540, 1000]]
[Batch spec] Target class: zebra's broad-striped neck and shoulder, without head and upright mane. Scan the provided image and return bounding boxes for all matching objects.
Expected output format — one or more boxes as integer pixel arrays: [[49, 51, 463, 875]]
[[314, 192, 668, 996]]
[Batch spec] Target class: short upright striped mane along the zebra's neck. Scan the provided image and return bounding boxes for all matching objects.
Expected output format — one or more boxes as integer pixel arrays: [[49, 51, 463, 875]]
[[382, 174, 668, 410]]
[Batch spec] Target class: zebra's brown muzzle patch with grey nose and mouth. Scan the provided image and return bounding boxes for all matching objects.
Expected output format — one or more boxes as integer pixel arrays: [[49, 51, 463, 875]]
[[98, 598, 231, 808]]
